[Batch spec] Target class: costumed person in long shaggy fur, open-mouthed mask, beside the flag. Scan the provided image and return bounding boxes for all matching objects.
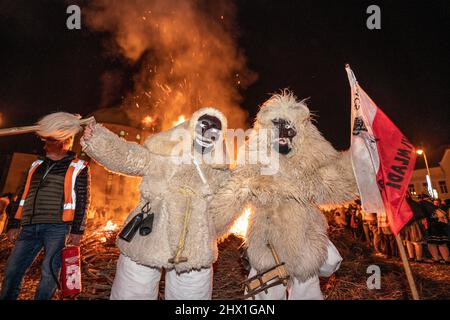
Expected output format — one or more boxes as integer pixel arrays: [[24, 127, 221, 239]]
[[209, 90, 357, 300]]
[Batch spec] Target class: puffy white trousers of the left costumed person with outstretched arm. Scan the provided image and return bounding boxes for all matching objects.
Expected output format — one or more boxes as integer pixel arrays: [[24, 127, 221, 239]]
[[110, 254, 213, 300]]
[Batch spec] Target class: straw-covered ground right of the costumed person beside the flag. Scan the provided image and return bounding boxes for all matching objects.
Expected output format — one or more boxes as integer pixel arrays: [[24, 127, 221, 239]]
[[323, 226, 450, 300]]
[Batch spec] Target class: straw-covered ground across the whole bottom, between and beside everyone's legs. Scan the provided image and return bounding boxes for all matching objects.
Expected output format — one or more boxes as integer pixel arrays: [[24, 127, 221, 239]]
[[0, 219, 450, 300]]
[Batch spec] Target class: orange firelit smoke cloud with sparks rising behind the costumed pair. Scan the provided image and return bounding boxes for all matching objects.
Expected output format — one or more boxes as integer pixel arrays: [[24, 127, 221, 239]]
[[83, 0, 256, 130]]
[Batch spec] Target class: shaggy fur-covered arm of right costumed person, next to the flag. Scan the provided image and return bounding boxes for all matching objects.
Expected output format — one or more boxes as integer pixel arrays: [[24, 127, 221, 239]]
[[314, 151, 358, 205]]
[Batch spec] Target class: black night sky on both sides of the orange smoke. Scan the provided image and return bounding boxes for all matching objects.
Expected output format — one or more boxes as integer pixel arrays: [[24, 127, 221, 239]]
[[0, 0, 450, 165]]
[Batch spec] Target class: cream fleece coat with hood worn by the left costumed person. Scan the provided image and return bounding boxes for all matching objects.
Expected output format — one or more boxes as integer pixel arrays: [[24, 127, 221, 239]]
[[81, 108, 230, 272]]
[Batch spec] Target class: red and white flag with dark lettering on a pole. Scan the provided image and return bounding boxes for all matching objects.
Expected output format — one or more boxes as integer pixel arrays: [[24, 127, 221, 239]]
[[346, 65, 416, 234]]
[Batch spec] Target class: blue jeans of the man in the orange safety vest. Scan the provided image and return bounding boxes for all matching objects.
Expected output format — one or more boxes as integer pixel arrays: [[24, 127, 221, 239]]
[[0, 224, 70, 300]]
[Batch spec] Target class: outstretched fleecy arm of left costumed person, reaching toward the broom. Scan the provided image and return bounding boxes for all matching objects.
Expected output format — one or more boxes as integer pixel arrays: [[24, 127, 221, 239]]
[[80, 124, 151, 176]]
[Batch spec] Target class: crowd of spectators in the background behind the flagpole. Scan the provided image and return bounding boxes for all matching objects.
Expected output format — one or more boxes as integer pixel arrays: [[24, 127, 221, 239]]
[[331, 193, 450, 264]]
